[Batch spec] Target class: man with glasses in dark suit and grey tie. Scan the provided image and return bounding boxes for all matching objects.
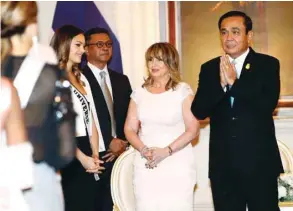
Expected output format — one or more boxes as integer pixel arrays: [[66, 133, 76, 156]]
[[83, 28, 132, 211]]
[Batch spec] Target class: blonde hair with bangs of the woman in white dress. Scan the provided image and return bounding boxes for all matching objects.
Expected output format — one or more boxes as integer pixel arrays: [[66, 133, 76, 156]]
[[142, 42, 181, 90]]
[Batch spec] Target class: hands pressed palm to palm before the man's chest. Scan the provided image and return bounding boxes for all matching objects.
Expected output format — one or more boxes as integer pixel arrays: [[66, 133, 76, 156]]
[[220, 55, 237, 88]]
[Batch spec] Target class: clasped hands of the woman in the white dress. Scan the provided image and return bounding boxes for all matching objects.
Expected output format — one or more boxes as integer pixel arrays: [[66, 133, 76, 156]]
[[140, 146, 170, 169]]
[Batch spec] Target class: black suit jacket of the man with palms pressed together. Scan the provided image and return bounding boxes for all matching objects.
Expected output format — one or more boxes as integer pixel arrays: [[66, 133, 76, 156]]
[[191, 48, 283, 178]]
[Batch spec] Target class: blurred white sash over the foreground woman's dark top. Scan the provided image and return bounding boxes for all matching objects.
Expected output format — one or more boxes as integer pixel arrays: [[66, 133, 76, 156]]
[[13, 44, 57, 109]]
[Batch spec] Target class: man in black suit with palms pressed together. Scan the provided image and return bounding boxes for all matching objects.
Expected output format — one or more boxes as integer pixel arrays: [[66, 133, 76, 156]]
[[191, 11, 283, 211]]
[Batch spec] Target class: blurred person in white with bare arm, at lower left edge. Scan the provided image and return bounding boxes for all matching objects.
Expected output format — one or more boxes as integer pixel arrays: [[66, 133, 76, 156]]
[[0, 77, 33, 211]]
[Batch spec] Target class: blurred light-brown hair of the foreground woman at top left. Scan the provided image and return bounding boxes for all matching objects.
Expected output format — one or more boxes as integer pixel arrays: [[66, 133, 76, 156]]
[[1, 1, 38, 62]]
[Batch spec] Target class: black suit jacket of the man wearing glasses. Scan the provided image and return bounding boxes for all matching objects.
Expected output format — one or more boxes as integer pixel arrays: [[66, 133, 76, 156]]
[[83, 66, 132, 150]]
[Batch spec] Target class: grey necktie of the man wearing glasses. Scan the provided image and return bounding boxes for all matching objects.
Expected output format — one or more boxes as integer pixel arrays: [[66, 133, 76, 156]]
[[100, 71, 116, 137]]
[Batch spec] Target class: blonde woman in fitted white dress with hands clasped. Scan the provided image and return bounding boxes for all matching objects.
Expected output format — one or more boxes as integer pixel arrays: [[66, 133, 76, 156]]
[[124, 43, 199, 211]]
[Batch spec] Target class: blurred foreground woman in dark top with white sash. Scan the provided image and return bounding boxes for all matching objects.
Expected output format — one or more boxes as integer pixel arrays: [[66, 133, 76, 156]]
[[1, 1, 76, 211]]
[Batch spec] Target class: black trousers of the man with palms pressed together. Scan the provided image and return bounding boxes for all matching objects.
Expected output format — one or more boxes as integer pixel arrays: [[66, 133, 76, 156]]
[[211, 173, 280, 211]]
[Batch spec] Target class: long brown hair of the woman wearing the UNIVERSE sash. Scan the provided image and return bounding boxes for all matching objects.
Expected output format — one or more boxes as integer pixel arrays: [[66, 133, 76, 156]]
[[50, 25, 84, 84]]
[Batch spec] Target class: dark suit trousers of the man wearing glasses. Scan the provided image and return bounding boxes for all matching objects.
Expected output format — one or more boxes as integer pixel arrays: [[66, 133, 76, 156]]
[[95, 152, 116, 211]]
